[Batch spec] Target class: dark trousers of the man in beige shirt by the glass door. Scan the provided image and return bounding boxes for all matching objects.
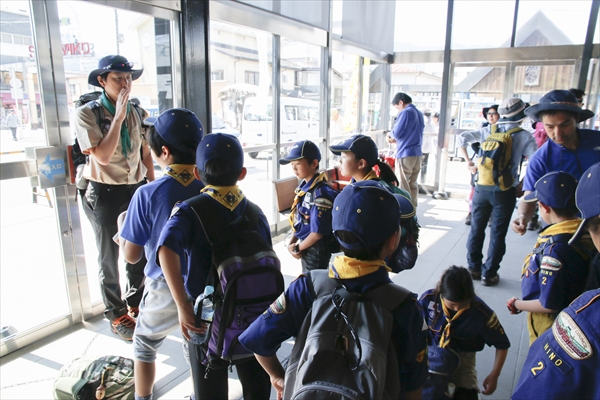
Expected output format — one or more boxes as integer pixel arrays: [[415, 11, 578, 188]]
[[83, 181, 146, 321]]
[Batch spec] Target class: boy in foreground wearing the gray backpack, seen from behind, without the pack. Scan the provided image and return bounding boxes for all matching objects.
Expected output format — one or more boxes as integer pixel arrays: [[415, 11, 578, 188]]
[[240, 181, 427, 399]]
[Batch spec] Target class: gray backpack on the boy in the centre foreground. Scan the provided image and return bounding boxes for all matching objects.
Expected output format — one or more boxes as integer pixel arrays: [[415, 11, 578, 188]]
[[283, 270, 410, 400]]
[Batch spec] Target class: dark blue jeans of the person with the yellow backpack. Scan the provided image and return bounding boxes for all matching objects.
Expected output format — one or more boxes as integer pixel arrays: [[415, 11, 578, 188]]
[[467, 186, 517, 279]]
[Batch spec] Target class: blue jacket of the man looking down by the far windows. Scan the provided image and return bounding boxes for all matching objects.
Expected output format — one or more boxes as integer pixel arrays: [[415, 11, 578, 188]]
[[392, 103, 425, 158]]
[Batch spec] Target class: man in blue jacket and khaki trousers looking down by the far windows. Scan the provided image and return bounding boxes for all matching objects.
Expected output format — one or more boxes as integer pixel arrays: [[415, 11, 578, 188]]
[[391, 92, 425, 209]]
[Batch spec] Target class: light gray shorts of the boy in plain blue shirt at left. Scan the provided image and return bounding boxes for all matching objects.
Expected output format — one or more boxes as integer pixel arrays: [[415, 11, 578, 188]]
[[133, 277, 179, 363]]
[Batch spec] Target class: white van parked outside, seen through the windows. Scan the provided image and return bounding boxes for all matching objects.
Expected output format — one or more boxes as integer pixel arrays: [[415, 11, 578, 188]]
[[241, 97, 319, 158]]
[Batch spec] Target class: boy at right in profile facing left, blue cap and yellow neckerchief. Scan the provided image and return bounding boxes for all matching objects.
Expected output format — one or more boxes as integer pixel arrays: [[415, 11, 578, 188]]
[[506, 172, 595, 345]]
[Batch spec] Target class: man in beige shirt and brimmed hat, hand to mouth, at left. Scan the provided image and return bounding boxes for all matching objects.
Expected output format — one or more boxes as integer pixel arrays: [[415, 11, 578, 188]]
[[75, 55, 154, 340]]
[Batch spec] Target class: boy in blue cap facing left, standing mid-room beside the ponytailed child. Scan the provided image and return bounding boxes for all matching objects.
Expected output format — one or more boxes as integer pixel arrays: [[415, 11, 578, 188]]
[[279, 140, 337, 272]]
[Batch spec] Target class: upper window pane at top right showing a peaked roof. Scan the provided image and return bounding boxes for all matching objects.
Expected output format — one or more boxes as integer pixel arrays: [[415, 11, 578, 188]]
[[512, 0, 592, 46]]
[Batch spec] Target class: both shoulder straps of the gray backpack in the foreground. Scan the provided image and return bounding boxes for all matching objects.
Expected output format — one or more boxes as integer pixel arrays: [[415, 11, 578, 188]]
[[307, 270, 411, 312]]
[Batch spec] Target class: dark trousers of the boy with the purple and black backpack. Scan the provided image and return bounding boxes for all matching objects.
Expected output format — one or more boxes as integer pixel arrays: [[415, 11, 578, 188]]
[[195, 358, 271, 400]]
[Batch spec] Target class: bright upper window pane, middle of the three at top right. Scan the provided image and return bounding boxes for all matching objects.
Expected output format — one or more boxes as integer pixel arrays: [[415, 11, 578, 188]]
[[452, 0, 516, 49]]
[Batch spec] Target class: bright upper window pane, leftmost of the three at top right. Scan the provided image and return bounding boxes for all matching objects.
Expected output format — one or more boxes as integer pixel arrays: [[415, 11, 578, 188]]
[[394, 0, 446, 52]]
